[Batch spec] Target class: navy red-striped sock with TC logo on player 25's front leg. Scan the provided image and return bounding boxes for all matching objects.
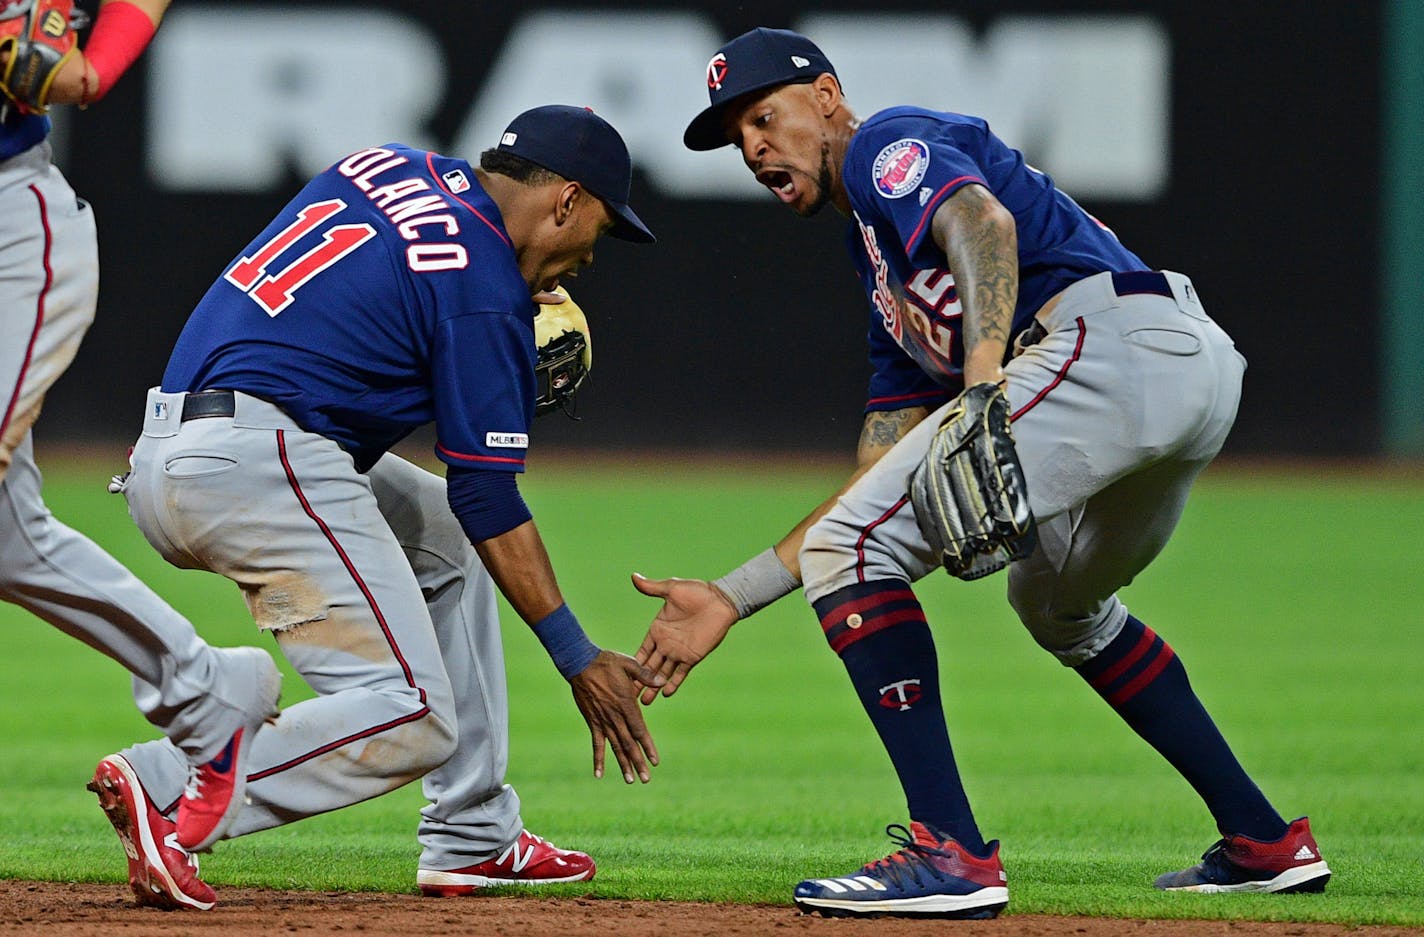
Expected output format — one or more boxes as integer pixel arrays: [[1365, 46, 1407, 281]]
[[813, 580, 985, 856]]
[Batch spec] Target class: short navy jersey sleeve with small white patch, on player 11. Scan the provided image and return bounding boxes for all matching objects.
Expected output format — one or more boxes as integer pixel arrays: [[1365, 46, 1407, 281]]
[[431, 306, 534, 471]]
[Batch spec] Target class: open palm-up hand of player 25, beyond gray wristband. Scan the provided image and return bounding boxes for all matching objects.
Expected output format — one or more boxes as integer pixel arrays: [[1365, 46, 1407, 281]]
[[632, 572, 736, 706]]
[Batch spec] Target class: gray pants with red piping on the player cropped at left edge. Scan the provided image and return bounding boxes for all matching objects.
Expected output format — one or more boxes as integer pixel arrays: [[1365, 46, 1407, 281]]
[[0, 142, 269, 762]]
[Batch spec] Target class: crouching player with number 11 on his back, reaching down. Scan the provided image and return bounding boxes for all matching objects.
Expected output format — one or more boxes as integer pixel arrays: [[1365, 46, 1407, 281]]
[[100, 105, 661, 900]]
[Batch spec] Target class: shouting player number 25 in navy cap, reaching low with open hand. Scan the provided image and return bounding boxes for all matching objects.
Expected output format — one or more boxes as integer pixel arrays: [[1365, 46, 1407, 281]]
[[635, 28, 1330, 917]]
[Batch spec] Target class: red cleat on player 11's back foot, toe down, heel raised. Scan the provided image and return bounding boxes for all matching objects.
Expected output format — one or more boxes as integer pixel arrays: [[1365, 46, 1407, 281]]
[[87, 755, 218, 911]]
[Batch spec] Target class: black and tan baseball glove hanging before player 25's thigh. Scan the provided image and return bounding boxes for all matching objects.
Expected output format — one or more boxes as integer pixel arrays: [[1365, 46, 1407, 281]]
[[910, 383, 1038, 580]]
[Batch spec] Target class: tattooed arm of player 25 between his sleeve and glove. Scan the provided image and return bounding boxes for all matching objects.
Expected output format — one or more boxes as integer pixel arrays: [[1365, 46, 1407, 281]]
[[934, 185, 1018, 355]]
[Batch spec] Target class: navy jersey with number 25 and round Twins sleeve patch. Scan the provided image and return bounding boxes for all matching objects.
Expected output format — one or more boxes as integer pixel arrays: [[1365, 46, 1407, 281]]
[[842, 107, 1148, 412]]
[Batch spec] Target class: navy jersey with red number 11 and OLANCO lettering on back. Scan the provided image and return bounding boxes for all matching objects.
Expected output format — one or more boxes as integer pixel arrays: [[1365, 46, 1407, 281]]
[[162, 144, 535, 471]]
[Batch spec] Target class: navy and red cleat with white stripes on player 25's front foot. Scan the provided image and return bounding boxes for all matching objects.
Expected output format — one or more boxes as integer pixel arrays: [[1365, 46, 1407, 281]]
[[795, 823, 1008, 918]]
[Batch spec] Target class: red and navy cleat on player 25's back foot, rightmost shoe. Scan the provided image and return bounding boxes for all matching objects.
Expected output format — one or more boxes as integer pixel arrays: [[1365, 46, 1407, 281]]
[[1155, 817, 1330, 893]]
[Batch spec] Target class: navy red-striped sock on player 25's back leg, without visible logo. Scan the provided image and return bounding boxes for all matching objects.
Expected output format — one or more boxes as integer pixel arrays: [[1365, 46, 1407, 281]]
[[1075, 615, 1286, 842]]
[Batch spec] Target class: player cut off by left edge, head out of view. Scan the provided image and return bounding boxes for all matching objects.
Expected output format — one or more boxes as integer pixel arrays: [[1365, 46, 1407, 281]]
[[0, 0, 281, 907]]
